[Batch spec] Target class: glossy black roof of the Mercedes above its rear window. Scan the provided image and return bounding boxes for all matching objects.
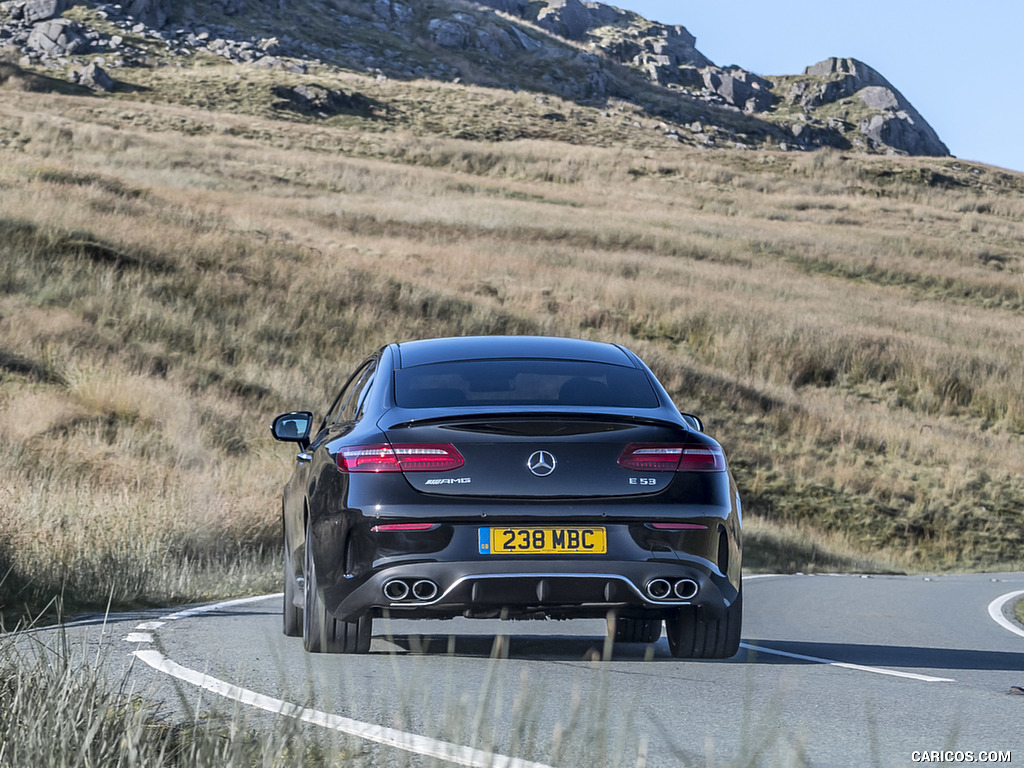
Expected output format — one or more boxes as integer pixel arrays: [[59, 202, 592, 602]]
[[395, 336, 637, 368]]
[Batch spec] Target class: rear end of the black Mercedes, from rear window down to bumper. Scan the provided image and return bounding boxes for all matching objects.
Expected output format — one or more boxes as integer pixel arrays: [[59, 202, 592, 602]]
[[316, 345, 740, 634]]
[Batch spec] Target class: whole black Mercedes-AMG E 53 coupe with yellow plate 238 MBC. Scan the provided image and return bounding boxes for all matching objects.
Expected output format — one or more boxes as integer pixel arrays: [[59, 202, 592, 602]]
[[271, 336, 742, 658]]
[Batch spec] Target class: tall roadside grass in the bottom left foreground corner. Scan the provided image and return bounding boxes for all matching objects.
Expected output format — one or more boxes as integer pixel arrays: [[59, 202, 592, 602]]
[[0, 630, 329, 768]]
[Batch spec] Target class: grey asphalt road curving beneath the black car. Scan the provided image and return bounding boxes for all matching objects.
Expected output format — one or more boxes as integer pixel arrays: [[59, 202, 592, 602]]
[[22, 573, 1024, 768]]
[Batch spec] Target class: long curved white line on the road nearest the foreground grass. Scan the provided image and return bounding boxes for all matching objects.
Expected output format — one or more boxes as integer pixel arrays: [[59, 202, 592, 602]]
[[134, 651, 551, 768]]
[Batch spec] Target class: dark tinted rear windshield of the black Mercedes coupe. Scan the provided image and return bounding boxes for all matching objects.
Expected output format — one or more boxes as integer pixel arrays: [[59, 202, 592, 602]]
[[394, 360, 658, 408]]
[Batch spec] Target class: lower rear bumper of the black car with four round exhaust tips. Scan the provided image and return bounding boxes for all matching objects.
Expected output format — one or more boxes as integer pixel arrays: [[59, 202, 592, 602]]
[[325, 559, 736, 621]]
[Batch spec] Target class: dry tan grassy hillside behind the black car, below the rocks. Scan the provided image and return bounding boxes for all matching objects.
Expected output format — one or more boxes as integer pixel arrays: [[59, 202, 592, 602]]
[[0, 65, 1024, 623]]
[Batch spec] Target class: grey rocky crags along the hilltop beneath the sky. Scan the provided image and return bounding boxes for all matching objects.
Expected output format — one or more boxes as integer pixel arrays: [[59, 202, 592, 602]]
[[0, 0, 948, 155]]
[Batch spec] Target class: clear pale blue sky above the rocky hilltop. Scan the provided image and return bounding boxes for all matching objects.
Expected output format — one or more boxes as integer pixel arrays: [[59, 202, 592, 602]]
[[609, 0, 1024, 171]]
